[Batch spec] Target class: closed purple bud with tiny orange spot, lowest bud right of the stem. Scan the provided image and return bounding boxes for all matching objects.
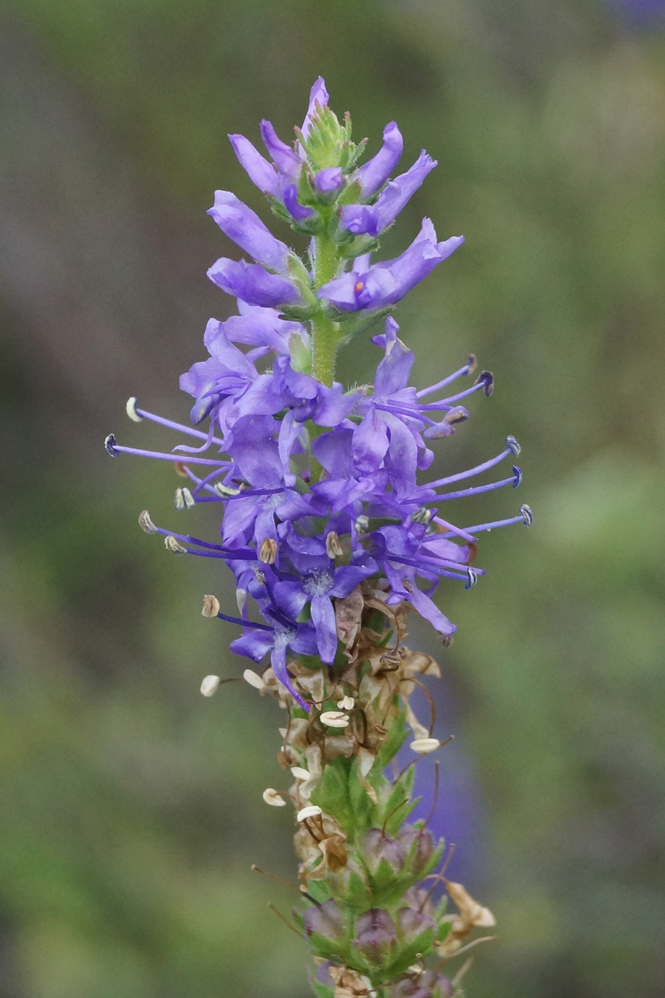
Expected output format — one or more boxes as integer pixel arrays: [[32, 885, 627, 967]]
[[317, 218, 464, 312]]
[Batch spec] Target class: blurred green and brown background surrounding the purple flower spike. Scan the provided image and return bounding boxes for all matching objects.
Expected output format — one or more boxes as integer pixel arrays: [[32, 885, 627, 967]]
[[0, 0, 665, 998]]
